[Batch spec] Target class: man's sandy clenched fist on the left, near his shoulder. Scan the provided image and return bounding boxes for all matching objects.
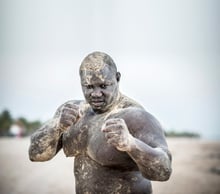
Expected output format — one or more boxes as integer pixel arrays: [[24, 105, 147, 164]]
[[56, 103, 79, 130]]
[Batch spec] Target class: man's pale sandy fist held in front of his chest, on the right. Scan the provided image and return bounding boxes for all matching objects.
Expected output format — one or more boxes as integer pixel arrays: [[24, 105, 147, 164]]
[[101, 118, 134, 151]]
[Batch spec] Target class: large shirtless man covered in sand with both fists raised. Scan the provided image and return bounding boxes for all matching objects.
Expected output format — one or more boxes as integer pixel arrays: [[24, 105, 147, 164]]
[[29, 52, 171, 194]]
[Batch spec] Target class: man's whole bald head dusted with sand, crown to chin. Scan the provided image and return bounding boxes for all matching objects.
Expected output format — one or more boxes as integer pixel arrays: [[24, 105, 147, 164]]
[[80, 52, 120, 113]]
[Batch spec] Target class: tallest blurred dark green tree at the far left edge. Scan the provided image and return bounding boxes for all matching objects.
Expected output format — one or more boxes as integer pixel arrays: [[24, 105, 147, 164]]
[[0, 110, 13, 136]]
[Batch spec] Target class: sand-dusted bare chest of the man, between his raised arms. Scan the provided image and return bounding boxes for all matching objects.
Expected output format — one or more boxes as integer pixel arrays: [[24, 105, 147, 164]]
[[63, 115, 131, 166]]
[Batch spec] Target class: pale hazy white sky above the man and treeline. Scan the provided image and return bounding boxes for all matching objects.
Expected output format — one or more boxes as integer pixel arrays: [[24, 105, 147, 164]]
[[0, 0, 220, 139]]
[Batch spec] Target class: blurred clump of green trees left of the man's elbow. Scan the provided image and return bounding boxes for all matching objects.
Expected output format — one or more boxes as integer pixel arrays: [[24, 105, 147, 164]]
[[0, 110, 41, 136]]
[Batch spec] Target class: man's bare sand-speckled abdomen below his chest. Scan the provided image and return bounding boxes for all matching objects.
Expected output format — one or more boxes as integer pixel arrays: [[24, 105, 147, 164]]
[[74, 155, 152, 194]]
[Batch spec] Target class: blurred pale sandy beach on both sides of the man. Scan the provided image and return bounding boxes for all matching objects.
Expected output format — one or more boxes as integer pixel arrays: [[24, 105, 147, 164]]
[[0, 138, 220, 194]]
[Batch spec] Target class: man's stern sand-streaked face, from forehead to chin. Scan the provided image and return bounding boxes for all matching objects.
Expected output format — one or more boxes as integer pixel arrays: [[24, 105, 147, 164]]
[[81, 65, 119, 113]]
